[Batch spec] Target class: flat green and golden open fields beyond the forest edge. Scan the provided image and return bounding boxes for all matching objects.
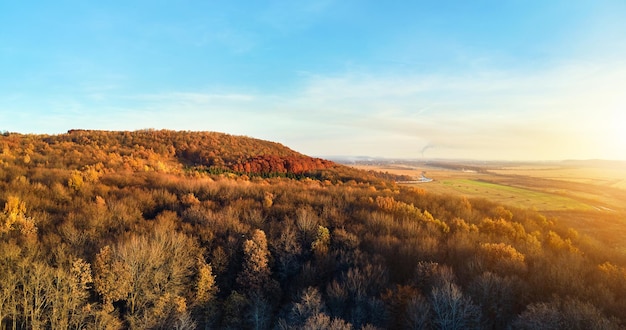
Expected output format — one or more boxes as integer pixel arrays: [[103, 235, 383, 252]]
[[352, 161, 626, 253]]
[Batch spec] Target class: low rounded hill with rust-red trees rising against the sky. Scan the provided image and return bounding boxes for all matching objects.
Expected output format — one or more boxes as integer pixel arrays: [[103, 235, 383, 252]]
[[1, 130, 337, 174]]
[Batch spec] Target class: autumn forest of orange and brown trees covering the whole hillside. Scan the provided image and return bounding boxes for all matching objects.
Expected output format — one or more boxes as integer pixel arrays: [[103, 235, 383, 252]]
[[0, 130, 626, 329]]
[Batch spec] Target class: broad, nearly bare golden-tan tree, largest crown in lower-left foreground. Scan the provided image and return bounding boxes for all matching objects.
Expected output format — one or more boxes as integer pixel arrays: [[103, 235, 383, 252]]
[[94, 218, 199, 327]]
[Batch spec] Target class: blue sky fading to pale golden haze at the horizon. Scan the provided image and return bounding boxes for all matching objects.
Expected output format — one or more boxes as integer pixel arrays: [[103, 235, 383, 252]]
[[0, 0, 626, 160]]
